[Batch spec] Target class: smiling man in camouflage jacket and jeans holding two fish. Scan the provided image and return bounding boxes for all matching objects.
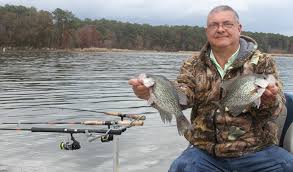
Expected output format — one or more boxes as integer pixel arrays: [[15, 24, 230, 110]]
[[129, 6, 293, 172]]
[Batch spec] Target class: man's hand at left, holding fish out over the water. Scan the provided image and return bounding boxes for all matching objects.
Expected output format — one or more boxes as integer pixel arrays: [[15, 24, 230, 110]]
[[128, 79, 150, 100]]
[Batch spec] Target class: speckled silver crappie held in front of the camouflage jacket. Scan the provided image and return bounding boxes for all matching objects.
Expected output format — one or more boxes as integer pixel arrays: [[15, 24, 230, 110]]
[[219, 74, 275, 116]]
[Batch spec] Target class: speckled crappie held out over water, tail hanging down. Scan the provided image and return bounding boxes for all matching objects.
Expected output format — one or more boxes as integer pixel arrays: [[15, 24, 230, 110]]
[[138, 74, 191, 135]]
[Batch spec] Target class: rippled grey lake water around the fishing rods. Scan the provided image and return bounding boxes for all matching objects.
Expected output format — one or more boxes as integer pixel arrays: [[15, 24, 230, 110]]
[[0, 52, 293, 172]]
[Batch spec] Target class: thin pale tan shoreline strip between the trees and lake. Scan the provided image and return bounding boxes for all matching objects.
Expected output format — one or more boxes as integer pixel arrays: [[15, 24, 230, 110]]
[[2, 47, 293, 57]]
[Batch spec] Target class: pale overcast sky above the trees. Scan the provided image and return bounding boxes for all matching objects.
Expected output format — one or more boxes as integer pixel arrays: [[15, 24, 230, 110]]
[[0, 0, 293, 36]]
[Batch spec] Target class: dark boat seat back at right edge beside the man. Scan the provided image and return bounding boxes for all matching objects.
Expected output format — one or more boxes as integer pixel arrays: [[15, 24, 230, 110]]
[[277, 93, 293, 153]]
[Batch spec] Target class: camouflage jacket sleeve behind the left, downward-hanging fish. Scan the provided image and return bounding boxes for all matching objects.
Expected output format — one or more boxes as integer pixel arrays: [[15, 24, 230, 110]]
[[175, 56, 197, 109]]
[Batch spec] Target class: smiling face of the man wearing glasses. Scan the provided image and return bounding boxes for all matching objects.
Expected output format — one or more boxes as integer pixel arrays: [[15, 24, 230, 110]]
[[206, 11, 241, 48]]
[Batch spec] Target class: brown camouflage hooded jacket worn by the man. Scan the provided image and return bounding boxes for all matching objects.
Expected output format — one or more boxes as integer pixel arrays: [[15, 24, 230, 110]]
[[176, 36, 285, 157]]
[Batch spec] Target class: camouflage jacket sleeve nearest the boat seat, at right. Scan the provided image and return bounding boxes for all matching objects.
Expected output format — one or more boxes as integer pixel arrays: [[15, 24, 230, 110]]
[[250, 54, 285, 118]]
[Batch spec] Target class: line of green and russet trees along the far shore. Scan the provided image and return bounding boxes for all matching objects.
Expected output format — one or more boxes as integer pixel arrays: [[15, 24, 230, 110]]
[[0, 5, 293, 53]]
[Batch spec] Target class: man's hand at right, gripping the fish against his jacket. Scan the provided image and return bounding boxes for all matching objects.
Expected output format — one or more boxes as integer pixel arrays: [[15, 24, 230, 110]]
[[261, 84, 279, 104]]
